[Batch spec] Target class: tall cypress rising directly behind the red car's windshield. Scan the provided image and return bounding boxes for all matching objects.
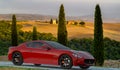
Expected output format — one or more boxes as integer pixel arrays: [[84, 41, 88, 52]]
[[57, 4, 67, 45]]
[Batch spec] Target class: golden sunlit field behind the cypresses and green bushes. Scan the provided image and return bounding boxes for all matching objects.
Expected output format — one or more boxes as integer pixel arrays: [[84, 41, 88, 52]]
[[18, 21, 120, 41]]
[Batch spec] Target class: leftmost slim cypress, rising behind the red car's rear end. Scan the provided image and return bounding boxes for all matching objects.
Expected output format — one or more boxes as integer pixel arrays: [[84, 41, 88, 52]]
[[11, 15, 18, 46]]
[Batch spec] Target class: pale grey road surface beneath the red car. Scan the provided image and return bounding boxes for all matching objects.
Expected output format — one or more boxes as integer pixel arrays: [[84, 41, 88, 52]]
[[0, 61, 120, 70]]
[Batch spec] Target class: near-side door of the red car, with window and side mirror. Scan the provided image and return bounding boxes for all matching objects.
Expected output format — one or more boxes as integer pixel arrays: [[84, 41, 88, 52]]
[[32, 42, 57, 64]]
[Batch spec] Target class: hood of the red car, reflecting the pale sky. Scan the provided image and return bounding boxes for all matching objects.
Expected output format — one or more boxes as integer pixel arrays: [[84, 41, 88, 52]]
[[70, 50, 94, 59]]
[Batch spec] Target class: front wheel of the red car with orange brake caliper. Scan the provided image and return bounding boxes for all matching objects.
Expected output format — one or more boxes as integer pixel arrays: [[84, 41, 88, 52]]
[[59, 55, 73, 69]]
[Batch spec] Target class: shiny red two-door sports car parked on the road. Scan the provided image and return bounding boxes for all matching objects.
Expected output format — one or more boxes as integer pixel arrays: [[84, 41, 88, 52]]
[[8, 40, 95, 69]]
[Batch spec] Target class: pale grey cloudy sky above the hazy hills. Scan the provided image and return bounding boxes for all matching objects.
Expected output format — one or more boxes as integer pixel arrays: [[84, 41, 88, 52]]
[[0, 0, 120, 18]]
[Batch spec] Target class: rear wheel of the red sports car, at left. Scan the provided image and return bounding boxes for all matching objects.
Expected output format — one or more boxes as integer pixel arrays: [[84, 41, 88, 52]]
[[12, 52, 23, 65]]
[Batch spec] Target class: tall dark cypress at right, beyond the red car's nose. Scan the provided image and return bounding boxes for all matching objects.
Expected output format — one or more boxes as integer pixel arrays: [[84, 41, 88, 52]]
[[94, 4, 104, 66]]
